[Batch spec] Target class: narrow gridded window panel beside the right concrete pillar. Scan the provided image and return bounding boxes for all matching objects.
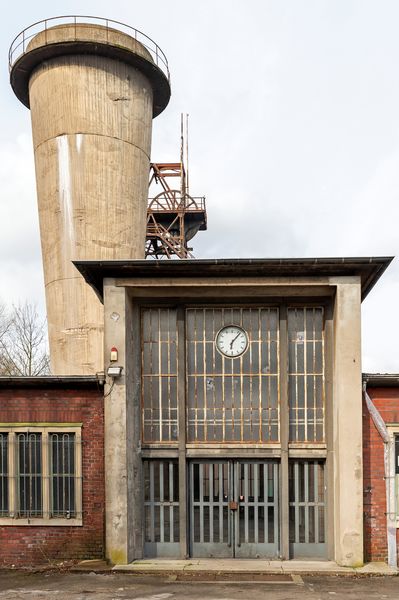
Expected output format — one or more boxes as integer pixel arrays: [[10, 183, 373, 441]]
[[288, 307, 325, 442]]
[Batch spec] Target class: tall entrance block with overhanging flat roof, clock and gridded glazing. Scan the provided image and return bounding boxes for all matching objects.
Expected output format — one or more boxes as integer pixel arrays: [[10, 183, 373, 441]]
[[71, 259, 390, 566]]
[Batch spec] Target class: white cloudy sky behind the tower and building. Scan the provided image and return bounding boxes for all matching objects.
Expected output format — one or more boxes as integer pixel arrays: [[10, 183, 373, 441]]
[[0, 0, 399, 373]]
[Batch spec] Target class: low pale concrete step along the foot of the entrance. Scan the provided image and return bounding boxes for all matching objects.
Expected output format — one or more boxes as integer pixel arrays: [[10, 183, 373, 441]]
[[112, 558, 398, 575]]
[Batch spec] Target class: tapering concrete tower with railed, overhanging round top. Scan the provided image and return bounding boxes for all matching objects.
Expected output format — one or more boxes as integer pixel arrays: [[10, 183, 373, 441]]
[[10, 17, 170, 375]]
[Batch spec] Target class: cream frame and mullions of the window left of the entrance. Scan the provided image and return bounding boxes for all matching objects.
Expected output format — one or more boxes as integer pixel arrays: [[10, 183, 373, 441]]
[[0, 423, 83, 527]]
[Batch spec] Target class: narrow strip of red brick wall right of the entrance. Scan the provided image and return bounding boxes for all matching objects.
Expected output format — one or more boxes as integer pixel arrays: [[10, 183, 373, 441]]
[[363, 387, 399, 561]]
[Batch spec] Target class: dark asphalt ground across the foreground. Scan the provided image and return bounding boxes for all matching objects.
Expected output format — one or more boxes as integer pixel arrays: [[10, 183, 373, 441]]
[[0, 572, 399, 600]]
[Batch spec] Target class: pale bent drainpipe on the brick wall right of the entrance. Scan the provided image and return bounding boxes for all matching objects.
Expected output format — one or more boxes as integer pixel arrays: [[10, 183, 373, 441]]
[[363, 381, 397, 569]]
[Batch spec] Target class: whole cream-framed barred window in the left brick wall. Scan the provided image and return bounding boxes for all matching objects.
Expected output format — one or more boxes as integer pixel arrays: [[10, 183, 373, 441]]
[[0, 425, 82, 525]]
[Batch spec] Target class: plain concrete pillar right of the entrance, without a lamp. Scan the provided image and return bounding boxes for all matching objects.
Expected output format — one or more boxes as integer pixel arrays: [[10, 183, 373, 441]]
[[330, 277, 363, 567]]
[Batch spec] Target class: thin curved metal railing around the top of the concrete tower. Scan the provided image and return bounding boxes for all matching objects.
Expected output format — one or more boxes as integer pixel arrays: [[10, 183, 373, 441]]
[[8, 15, 170, 81]]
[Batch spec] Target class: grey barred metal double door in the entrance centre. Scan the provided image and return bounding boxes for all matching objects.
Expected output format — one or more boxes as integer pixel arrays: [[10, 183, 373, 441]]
[[189, 460, 279, 558]]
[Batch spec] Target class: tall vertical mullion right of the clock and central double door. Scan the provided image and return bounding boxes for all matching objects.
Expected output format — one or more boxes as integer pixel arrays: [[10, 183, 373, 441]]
[[275, 305, 290, 560]]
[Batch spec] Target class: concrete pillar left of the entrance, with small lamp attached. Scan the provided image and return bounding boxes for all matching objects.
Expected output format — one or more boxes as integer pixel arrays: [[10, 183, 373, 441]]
[[104, 279, 144, 564]]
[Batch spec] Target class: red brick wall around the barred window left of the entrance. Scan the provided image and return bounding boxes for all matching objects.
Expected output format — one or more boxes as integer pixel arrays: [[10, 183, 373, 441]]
[[0, 382, 104, 567]]
